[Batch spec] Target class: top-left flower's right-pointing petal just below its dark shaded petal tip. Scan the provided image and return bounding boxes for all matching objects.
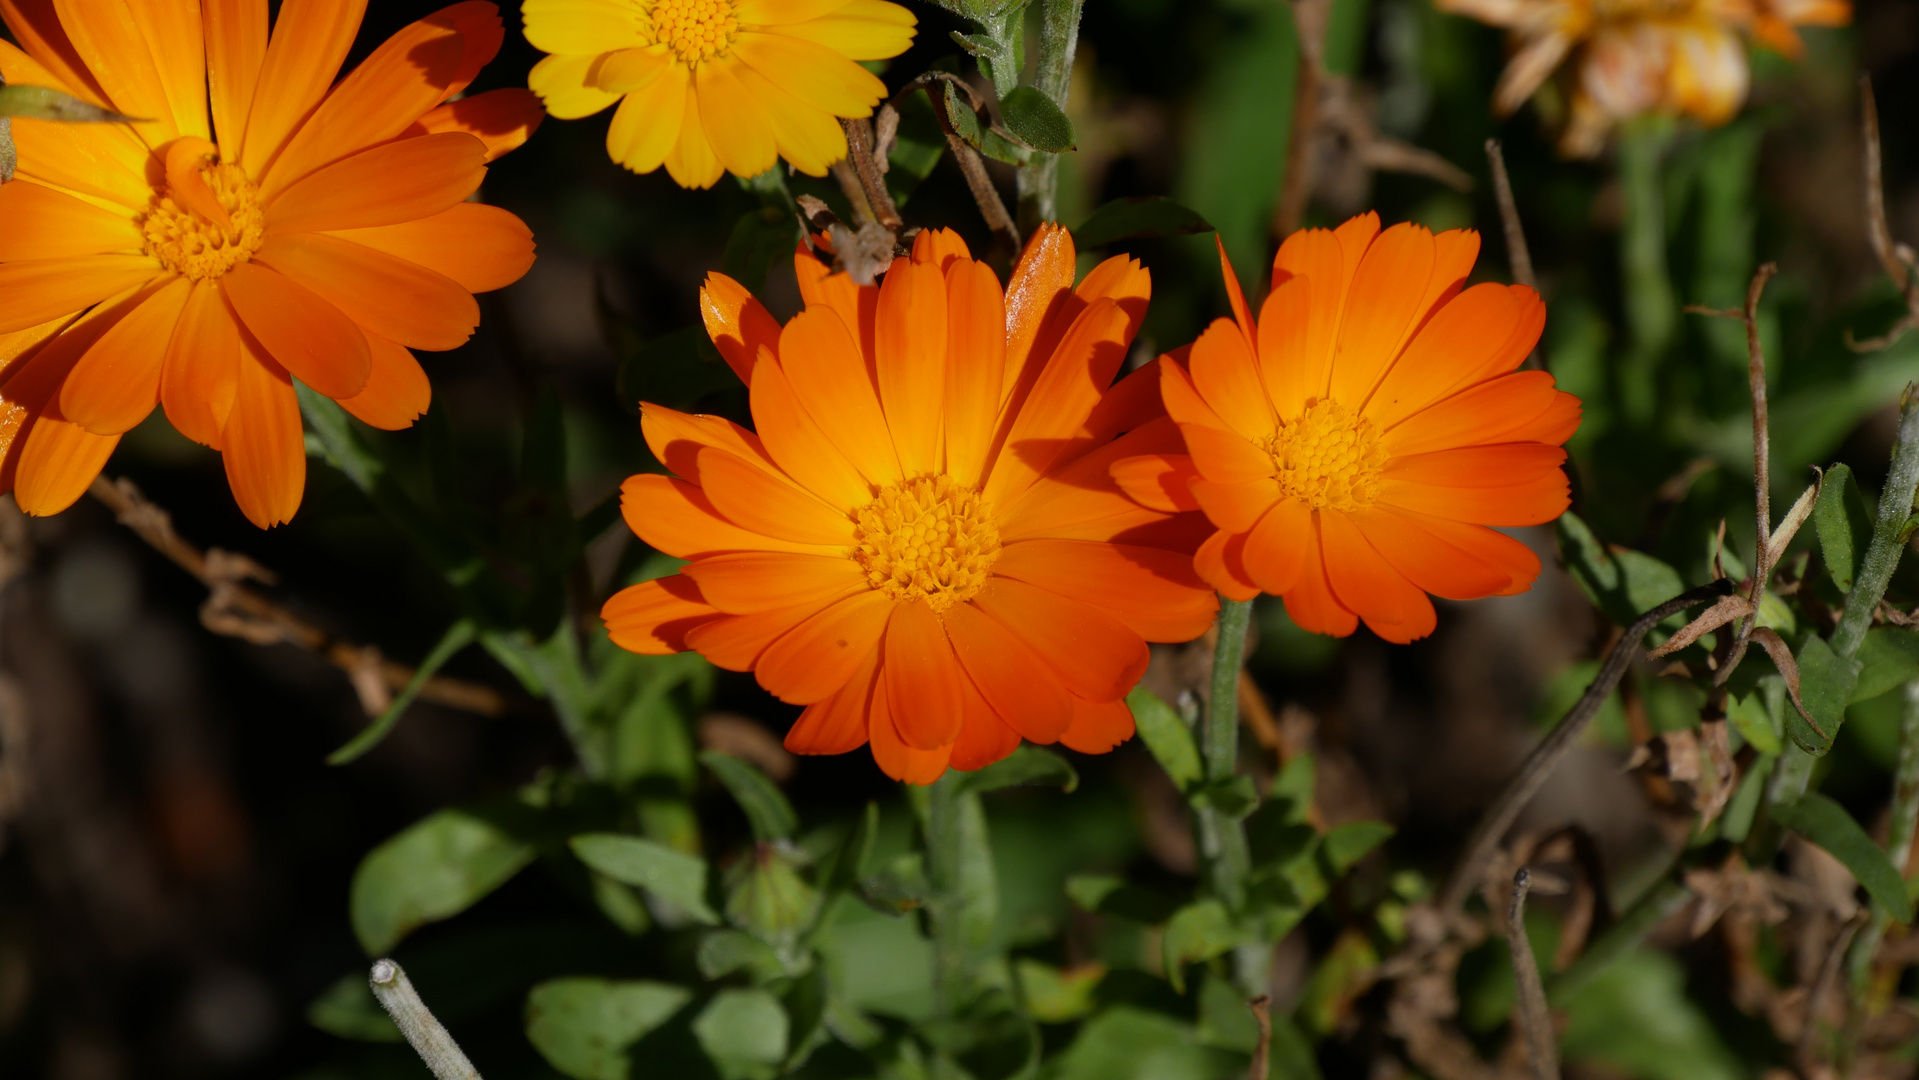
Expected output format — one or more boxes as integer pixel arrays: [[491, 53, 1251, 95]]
[[263, 132, 486, 236]]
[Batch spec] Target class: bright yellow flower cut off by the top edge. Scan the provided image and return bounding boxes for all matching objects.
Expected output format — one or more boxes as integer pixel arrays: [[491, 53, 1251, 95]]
[[522, 0, 915, 188]]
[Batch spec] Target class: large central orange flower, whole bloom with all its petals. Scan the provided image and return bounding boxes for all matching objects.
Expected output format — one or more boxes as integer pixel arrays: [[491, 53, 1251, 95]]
[[601, 226, 1217, 785]]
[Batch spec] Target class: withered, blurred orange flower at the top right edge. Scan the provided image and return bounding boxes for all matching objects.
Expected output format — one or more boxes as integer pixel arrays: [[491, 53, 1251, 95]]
[[1439, 0, 1852, 157]]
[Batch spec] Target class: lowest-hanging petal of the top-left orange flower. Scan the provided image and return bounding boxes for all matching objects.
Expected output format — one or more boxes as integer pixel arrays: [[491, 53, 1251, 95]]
[[221, 349, 307, 529]]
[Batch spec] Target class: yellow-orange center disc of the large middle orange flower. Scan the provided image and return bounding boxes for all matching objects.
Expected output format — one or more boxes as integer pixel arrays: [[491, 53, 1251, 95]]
[[852, 476, 1000, 612]]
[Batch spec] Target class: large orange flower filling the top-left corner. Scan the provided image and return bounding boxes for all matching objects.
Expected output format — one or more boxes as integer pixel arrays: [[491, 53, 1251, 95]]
[[0, 0, 541, 528]]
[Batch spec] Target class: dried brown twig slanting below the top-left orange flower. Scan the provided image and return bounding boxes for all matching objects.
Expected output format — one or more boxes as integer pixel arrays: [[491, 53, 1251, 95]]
[[88, 476, 507, 716]]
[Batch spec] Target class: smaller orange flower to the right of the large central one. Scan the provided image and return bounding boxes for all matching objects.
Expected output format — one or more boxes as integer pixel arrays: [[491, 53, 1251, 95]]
[[1113, 213, 1579, 643]]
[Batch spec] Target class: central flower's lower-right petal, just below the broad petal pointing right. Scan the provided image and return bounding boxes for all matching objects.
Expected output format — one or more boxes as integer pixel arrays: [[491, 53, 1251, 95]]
[[973, 577, 1148, 700]]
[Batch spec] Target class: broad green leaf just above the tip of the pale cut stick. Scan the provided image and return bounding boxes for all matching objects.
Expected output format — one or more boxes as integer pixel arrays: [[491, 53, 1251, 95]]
[[347, 804, 533, 955]]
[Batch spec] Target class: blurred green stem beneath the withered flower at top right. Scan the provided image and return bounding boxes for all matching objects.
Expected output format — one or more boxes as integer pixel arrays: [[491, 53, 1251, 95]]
[[1620, 117, 1679, 424]]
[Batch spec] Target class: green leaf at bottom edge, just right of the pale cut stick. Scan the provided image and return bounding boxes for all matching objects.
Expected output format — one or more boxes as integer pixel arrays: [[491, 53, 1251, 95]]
[[526, 978, 693, 1080]]
